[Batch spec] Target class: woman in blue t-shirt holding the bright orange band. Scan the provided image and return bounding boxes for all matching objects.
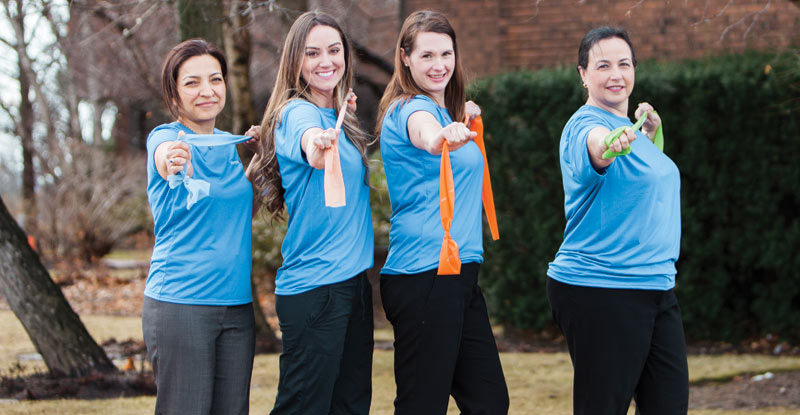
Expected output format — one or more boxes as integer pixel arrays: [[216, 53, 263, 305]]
[[378, 11, 508, 414]]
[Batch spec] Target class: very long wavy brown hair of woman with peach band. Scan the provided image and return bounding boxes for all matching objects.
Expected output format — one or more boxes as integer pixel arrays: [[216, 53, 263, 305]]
[[253, 11, 369, 220]]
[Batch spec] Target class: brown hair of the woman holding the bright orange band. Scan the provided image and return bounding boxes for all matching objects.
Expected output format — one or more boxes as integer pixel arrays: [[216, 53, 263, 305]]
[[375, 10, 466, 136]]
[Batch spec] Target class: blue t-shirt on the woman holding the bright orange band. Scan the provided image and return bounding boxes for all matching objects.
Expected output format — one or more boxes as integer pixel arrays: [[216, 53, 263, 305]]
[[381, 95, 483, 274]]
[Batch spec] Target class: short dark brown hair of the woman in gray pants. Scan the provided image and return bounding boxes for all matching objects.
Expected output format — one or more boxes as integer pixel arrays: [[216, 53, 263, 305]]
[[161, 39, 228, 118]]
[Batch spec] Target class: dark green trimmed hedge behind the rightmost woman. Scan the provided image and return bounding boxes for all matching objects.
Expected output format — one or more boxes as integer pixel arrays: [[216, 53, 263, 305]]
[[470, 53, 800, 341]]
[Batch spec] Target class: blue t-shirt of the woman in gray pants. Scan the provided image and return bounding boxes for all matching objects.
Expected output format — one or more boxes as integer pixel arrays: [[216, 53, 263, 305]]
[[144, 122, 253, 306]]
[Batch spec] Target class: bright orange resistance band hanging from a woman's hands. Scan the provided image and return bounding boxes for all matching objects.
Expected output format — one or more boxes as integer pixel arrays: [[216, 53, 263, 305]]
[[437, 117, 500, 275]]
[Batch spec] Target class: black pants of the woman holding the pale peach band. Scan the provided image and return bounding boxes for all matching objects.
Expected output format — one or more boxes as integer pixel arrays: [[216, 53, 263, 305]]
[[271, 272, 374, 415]]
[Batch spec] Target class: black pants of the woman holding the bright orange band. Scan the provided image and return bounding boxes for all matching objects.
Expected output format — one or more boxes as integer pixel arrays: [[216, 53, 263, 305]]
[[381, 263, 508, 415]]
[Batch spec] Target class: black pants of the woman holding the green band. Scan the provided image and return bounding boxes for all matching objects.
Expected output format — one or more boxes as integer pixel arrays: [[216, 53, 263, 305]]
[[547, 278, 689, 415]]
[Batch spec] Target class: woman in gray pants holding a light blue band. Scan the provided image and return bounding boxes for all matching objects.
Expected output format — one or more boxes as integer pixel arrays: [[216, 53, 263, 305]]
[[142, 39, 255, 414]]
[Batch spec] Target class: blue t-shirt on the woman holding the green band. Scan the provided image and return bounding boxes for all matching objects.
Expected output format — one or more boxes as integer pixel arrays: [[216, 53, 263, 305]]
[[547, 105, 681, 290]]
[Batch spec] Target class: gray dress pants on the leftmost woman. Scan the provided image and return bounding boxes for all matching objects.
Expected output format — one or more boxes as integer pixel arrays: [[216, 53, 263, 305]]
[[142, 297, 255, 415]]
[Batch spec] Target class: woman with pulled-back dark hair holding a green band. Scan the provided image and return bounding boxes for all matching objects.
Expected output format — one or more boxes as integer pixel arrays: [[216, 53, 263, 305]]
[[547, 27, 689, 415]]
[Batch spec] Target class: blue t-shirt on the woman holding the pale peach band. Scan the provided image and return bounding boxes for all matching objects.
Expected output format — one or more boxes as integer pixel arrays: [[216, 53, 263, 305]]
[[275, 99, 375, 295]]
